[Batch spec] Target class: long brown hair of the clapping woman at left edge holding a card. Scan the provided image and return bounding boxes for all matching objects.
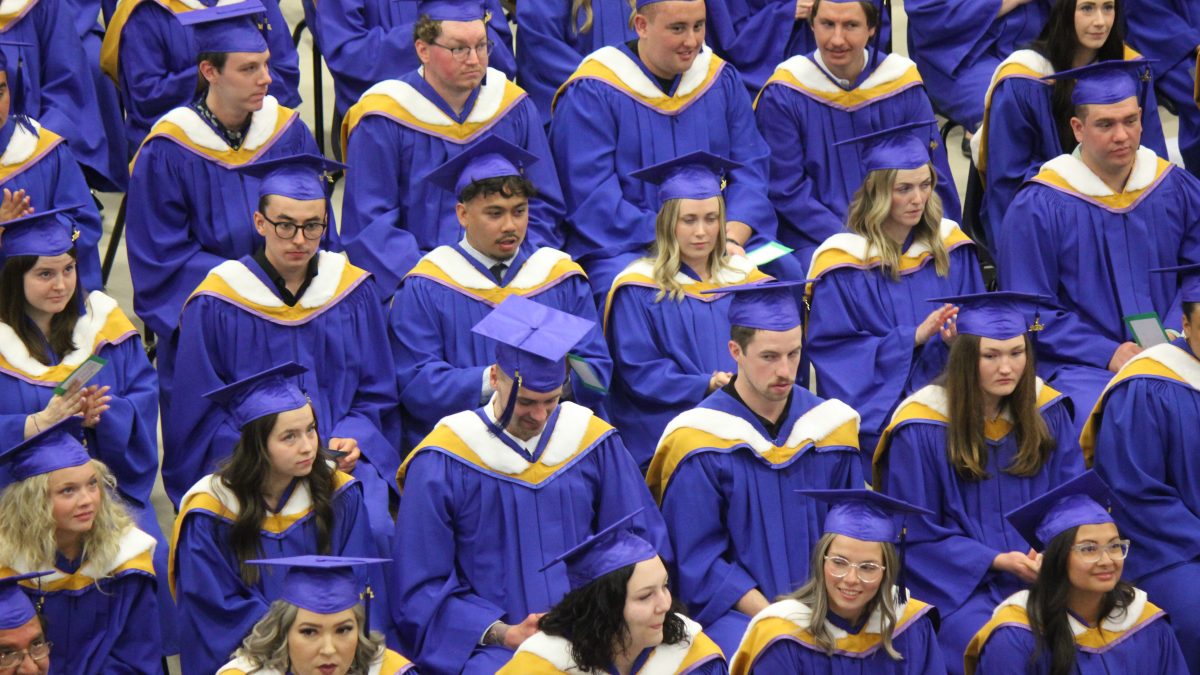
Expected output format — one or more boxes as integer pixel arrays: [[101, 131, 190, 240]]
[[0, 246, 84, 365]]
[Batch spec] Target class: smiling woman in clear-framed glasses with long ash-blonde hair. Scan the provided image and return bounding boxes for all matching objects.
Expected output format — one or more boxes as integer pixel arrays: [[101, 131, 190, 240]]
[[731, 489, 946, 675]]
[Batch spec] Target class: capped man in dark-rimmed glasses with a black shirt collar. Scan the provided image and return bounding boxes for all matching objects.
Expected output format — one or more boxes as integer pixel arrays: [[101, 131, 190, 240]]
[[163, 155, 400, 542]]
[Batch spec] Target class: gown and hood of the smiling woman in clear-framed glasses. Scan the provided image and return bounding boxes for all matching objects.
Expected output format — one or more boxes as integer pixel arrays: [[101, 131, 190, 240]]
[[730, 591, 946, 675]]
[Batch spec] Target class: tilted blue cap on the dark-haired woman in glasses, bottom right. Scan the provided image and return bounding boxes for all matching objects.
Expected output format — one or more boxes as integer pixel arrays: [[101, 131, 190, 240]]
[[1004, 471, 1117, 550]]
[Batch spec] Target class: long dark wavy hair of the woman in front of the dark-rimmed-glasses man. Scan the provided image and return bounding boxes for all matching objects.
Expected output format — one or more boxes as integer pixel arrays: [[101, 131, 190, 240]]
[[216, 413, 334, 584]]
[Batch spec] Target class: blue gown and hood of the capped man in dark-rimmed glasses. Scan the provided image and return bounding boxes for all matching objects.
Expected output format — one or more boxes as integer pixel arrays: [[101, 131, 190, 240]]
[[163, 251, 400, 550]]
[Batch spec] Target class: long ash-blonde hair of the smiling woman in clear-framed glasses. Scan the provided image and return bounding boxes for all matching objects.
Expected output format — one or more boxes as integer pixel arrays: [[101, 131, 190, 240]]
[[781, 532, 904, 661]]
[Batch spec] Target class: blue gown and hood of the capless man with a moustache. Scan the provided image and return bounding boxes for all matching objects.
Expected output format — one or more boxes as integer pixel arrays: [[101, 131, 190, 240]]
[[755, 51, 961, 267]]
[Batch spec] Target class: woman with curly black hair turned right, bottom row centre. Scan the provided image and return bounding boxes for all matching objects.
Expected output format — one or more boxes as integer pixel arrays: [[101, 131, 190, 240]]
[[498, 512, 728, 675]]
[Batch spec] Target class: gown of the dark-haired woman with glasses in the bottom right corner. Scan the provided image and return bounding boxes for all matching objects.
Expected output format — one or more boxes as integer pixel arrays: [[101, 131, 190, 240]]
[[966, 589, 1195, 675]]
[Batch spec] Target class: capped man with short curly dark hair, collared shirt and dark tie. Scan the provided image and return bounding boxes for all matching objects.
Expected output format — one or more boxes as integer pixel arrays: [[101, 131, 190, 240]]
[[389, 136, 612, 450]]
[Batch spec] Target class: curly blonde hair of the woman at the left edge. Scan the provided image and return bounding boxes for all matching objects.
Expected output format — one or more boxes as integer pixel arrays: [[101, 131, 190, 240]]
[[0, 459, 133, 569]]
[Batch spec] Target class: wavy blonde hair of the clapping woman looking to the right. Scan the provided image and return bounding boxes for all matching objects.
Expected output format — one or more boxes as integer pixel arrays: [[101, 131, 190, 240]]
[[846, 163, 950, 281]]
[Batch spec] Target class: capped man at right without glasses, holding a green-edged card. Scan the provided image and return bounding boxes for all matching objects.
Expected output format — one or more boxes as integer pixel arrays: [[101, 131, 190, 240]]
[[996, 61, 1200, 429]]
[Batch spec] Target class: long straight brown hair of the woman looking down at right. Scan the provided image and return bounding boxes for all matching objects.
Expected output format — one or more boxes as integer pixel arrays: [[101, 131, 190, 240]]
[[943, 335, 1056, 480]]
